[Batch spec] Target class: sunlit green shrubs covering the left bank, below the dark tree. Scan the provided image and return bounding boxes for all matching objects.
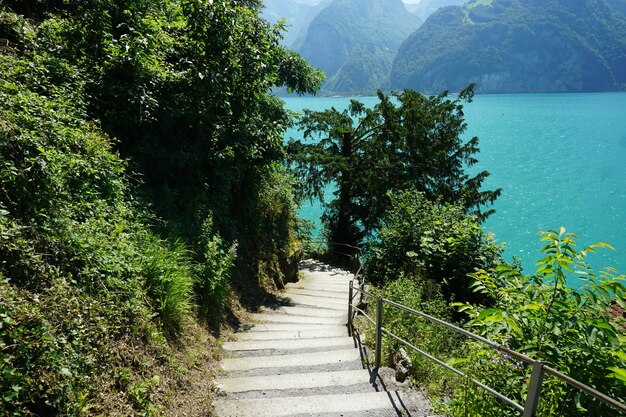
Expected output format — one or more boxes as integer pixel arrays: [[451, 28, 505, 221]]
[[0, 17, 193, 415]]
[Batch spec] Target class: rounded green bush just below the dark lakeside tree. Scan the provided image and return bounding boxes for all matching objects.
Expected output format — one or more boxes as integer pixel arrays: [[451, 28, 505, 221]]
[[365, 191, 501, 300]]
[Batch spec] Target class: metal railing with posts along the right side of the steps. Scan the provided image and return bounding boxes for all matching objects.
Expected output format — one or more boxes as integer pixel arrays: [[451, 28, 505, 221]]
[[348, 281, 626, 417]]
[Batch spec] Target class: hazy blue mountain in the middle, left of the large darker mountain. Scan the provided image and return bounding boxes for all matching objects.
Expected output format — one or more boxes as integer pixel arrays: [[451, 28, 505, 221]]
[[296, 0, 420, 94]]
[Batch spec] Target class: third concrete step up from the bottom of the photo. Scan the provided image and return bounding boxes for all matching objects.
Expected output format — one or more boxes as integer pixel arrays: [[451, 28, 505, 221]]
[[221, 348, 360, 371]]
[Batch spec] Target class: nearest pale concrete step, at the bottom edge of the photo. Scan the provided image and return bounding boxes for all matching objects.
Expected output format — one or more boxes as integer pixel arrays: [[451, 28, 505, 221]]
[[215, 391, 414, 417]]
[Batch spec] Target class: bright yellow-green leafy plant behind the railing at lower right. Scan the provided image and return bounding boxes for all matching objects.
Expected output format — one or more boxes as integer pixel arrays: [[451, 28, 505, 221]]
[[450, 228, 626, 416]]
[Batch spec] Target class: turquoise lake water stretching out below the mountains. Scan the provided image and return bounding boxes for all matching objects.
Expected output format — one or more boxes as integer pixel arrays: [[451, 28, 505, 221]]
[[284, 93, 626, 273]]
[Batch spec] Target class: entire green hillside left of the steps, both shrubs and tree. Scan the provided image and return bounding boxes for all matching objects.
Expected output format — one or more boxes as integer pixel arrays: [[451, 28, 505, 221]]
[[0, 0, 321, 416]]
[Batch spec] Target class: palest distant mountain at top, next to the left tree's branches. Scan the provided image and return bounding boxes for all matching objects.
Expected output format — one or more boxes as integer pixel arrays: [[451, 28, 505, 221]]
[[261, 0, 331, 48]]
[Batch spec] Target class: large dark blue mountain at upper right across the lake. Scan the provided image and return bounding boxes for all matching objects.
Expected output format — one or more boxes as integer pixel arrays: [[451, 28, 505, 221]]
[[390, 0, 626, 93]]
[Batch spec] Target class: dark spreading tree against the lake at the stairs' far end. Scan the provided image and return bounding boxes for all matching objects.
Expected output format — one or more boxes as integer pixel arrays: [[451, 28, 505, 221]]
[[289, 85, 500, 245]]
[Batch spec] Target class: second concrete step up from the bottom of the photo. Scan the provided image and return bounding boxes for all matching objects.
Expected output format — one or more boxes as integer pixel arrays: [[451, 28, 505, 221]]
[[218, 369, 370, 393]]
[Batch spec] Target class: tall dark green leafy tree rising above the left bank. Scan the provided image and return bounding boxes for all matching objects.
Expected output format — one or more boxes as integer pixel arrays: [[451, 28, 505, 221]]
[[7, 0, 322, 284]]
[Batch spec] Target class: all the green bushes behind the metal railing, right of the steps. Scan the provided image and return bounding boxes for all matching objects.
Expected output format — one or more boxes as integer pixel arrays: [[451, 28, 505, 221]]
[[358, 192, 626, 417]]
